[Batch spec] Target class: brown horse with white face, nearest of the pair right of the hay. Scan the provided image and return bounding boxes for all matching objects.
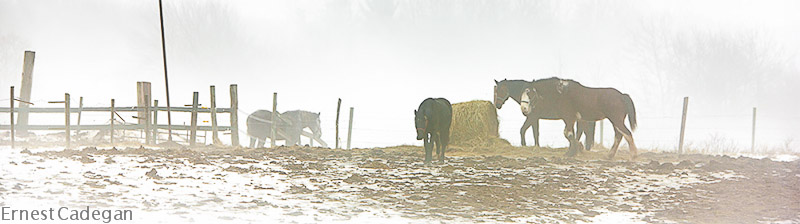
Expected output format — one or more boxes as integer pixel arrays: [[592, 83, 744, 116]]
[[520, 78, 637, 159]]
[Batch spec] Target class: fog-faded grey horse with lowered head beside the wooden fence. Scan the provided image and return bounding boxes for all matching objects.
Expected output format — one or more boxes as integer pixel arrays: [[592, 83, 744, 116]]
[[247, 110, 327, 148]]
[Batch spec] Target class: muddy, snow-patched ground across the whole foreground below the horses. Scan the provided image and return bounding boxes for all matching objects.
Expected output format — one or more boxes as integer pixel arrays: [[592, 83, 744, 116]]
[[0, 146, 800, 223]]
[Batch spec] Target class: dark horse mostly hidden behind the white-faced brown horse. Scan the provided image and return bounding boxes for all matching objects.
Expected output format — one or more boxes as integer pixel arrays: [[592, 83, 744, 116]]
[[494, 79, 595, 150]]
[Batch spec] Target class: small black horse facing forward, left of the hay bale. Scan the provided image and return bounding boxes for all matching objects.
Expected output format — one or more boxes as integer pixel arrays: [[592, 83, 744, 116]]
[[414, 98, 453, 164]]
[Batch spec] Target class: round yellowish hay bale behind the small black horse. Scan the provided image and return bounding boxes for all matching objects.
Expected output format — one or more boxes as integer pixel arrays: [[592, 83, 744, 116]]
[[450, 100, 508, 147]]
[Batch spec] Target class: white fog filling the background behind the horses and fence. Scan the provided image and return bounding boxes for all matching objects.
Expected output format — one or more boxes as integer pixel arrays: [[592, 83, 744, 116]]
[[0, 0, 800, 150]]
